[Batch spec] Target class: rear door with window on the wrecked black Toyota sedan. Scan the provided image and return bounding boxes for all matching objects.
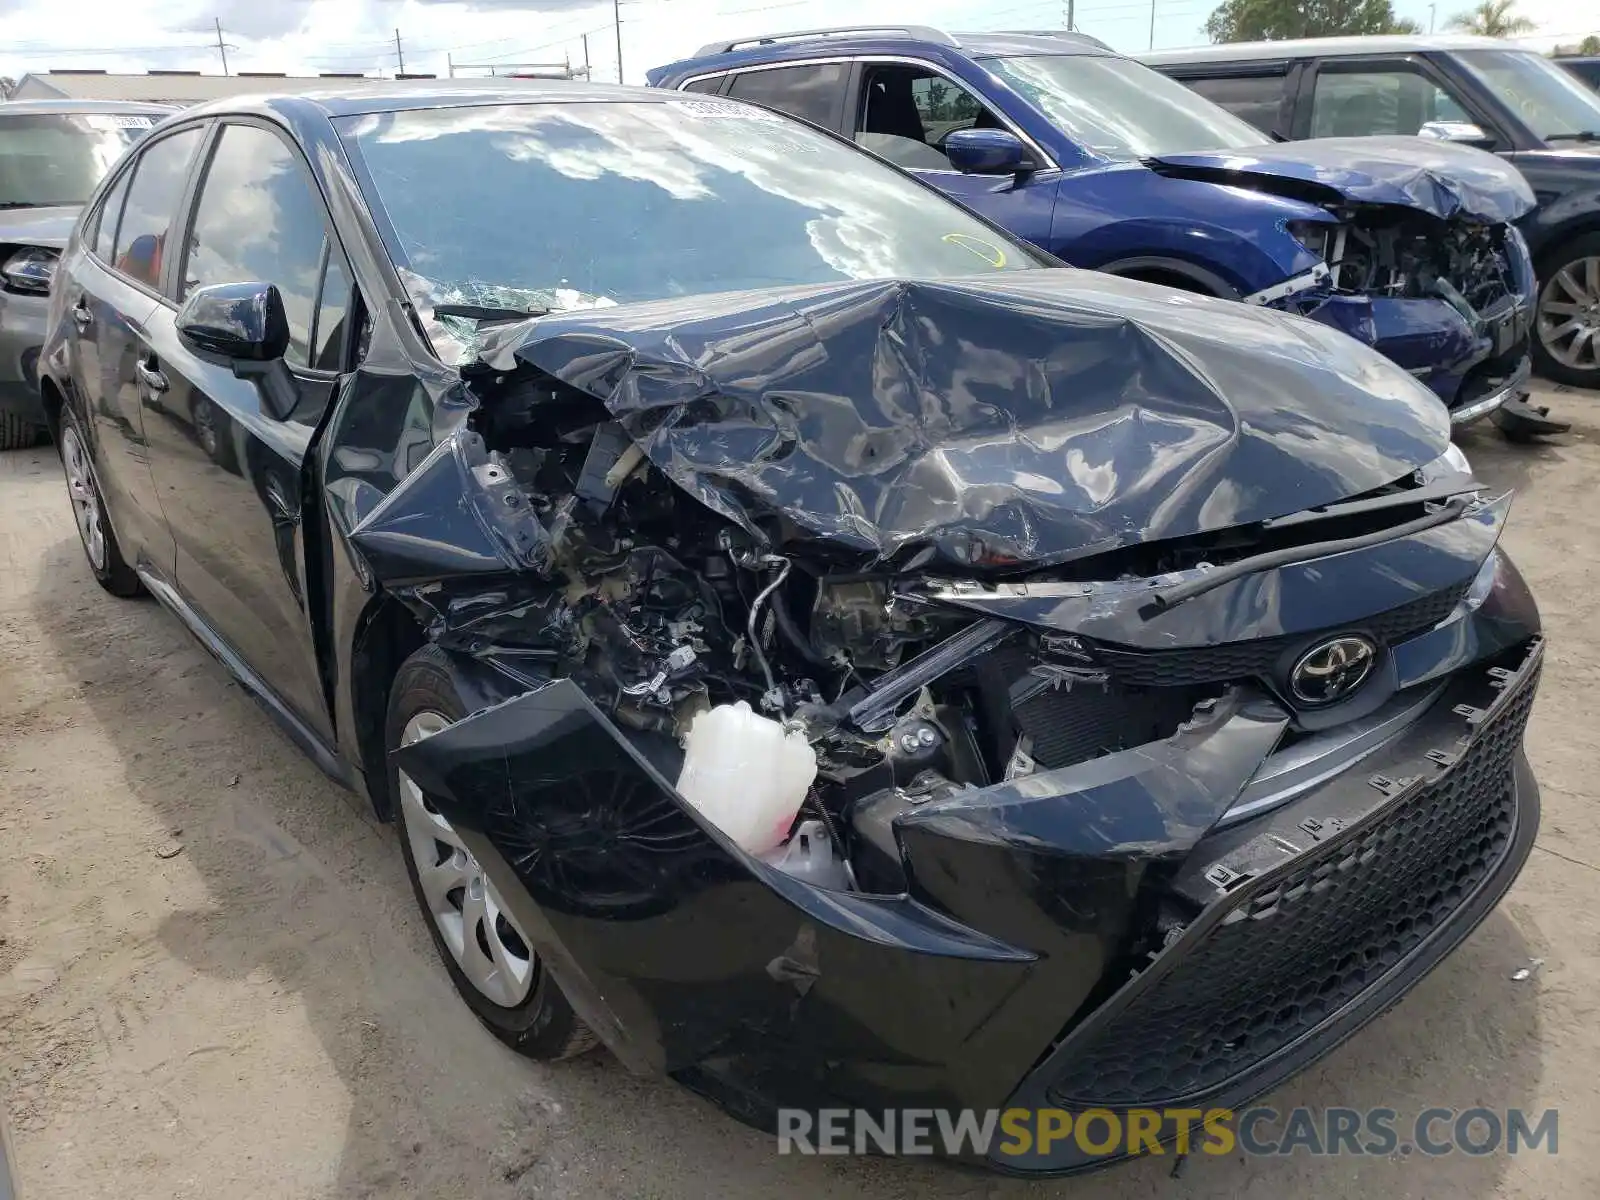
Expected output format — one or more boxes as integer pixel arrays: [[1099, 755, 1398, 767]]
[[62, 125, 205, 579]]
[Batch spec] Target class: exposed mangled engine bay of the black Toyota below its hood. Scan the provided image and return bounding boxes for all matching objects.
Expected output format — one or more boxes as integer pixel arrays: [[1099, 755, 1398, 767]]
[[419, 347, 1478, 893]]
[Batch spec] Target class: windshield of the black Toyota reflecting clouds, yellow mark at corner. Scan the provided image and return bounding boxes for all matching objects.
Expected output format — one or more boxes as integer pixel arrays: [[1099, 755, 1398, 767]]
[[341, 98, 1042, 331]]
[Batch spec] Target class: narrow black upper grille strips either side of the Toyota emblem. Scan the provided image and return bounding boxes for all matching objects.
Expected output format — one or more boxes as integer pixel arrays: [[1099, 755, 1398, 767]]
[[1094, 581, 1472, 688]]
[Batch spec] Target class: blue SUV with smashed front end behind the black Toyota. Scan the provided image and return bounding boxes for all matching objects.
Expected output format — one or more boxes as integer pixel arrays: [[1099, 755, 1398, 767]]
[[648, 26, 1536, 424]]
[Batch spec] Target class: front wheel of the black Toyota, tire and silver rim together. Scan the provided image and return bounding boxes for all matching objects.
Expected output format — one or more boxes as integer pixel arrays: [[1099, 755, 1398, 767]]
[[384, 646, 595, 1061]]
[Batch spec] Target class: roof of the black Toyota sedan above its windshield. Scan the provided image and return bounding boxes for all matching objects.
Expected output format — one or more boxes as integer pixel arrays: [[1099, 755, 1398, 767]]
[[184, 77, 682, 117]]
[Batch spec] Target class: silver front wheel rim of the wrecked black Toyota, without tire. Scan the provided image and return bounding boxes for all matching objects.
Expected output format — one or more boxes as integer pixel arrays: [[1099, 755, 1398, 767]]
[[398, 712, 538, 1008]]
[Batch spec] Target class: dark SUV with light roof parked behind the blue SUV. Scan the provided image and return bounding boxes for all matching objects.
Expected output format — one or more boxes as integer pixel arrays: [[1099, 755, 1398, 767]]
[[1142, 35, 1600, 387]]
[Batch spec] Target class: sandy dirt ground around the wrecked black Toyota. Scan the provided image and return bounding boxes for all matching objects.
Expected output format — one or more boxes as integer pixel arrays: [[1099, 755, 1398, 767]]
[[0, 394, 1600, 1200]]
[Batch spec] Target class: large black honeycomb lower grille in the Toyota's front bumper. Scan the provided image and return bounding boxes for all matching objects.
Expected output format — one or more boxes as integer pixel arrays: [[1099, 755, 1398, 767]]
[[1050, 678, 1536, 1107]]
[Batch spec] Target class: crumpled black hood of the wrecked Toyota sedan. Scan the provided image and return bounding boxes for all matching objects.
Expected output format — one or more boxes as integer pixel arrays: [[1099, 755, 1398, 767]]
[[477, 273, 1450, 566]]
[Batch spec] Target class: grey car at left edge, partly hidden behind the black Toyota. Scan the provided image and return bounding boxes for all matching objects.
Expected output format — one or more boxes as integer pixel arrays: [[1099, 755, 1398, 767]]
[[0, 101, 173, 450]]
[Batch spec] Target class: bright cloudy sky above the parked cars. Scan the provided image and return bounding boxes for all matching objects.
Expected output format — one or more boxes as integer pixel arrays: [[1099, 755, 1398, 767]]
[[0, 0, 1580, 83]]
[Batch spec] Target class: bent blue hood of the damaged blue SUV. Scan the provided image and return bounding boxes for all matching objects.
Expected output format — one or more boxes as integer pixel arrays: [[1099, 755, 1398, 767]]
[[1149, 138, 1534, 222]]
